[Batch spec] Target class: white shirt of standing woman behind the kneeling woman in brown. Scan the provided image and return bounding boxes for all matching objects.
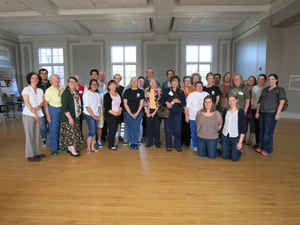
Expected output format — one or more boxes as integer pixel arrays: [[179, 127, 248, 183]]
[[186, 91, 209, 120]]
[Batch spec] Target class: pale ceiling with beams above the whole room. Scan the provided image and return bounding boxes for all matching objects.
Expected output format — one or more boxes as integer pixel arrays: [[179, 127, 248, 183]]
[[0, 0, 292, 37]]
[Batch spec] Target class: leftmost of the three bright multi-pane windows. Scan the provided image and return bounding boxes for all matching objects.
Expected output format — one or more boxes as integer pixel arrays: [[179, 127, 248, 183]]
[[38, 48, 65, 86]]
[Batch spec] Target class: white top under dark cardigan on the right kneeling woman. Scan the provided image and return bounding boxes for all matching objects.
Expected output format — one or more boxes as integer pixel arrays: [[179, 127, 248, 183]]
[[223, 109, 239, 138]]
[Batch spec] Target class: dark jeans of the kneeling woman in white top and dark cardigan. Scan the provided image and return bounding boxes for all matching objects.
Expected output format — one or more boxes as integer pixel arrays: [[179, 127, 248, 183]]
[[222, 134, 242, 161]]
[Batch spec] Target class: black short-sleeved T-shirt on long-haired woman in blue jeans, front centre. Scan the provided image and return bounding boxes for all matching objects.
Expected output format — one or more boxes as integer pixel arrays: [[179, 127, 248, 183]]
[[123, 88, 145, 112]]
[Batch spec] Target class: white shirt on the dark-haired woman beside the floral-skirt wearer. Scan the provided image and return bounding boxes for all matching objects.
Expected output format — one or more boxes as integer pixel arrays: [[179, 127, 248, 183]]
[[82, 90, 103, 116]]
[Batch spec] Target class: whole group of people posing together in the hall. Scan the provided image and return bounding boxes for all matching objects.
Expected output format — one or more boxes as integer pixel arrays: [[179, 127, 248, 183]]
[[22, 68, 286, 162]]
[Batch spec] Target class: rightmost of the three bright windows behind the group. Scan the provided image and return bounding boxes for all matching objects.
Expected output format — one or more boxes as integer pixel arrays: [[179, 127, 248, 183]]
[[186, 45, 212, 85]]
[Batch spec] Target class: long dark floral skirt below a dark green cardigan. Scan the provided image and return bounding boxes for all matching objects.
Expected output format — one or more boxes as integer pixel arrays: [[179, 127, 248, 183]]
[[59, 117, 82, 146]]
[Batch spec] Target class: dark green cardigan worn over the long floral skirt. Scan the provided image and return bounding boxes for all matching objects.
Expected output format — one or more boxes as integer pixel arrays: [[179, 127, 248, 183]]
[[60, 90, 83, 122]]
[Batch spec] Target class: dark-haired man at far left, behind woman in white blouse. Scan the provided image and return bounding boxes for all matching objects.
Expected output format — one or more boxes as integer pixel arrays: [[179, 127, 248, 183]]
[[37, 68, 51, 148]]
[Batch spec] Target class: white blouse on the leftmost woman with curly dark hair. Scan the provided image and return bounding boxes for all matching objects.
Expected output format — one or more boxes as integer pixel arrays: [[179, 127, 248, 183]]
[[22, 86, 44, 117]]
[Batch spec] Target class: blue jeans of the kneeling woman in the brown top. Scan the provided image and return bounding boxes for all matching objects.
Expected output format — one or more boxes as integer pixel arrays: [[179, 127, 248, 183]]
[[197, 137, 220, 159]]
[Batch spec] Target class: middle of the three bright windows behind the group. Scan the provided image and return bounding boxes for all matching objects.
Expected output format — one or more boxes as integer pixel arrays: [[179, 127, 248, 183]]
[[111, 46, 136, 86]]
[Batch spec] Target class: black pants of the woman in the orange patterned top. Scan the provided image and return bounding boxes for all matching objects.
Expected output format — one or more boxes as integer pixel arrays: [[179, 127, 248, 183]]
[[146, 109, 160, 146]]
